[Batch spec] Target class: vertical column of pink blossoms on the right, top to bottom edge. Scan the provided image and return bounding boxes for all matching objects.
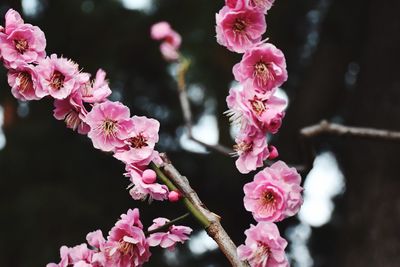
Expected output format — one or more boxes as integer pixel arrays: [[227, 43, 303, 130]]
[[216, 0, 303, 267]]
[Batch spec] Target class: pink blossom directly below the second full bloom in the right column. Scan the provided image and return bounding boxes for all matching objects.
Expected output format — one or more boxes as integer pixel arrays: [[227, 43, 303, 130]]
[[226, 83, 286, 133]]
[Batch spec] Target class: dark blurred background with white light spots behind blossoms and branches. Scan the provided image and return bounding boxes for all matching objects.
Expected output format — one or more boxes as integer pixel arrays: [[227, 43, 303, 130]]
[[0, 0, 400, 267]]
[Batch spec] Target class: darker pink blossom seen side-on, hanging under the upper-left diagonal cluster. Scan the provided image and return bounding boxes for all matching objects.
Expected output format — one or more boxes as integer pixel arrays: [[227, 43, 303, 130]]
[[54, 91, 90, 134]]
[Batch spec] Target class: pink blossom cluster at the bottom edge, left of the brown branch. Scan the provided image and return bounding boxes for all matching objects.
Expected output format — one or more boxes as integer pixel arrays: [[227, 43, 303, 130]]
[[47, 209, 192, 267]]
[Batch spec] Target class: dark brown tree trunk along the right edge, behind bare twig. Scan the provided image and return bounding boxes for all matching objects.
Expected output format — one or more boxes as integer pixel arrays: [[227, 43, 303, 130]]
[[340, 0, 400, 267]]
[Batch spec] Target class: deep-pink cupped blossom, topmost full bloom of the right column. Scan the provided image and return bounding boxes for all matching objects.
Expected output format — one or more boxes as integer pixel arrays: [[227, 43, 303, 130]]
[[216, 6, 267, 53]]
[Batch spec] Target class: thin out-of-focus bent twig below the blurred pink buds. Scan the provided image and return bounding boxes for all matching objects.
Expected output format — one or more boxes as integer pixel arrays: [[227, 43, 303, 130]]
[[177, 59, 233, 156]]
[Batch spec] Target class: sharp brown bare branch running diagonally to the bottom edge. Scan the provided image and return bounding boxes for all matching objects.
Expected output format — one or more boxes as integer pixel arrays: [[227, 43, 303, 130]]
[[160, 153, 249, 267]]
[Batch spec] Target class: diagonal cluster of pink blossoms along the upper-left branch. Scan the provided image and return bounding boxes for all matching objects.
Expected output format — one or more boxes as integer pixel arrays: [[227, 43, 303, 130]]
[[0, 9, 169, 203]]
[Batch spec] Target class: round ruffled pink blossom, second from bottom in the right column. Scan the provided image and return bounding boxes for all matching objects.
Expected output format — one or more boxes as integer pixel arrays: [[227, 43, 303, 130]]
[[243, 161, 303, 222]]
